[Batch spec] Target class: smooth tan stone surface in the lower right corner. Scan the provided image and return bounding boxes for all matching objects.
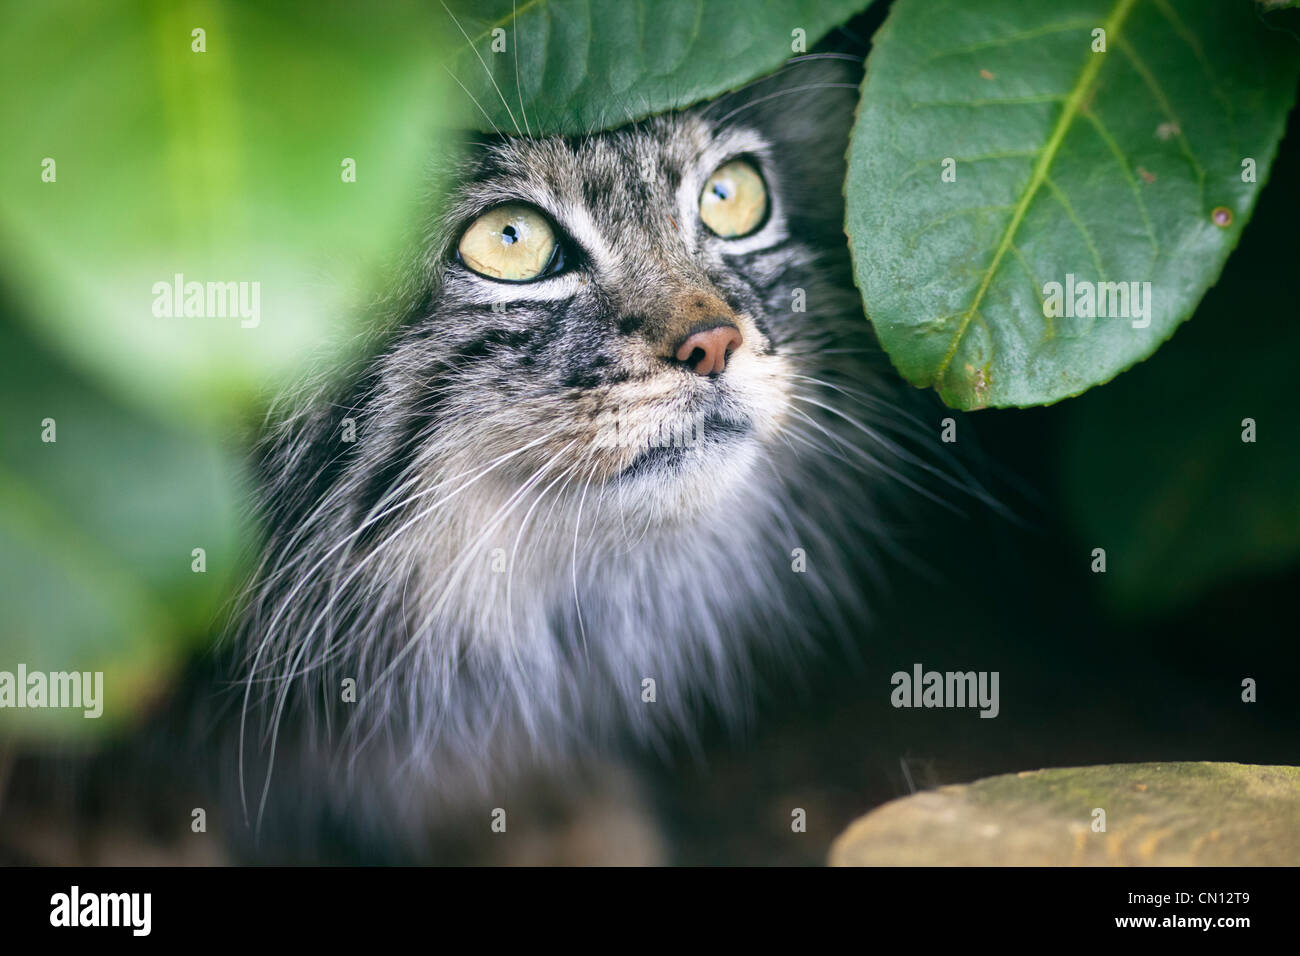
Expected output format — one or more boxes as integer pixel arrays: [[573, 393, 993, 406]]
[[829, 762, 1300, 866]]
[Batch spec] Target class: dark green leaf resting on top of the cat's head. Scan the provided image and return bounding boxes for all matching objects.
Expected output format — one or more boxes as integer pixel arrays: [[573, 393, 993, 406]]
[[445, 0, 871, 135]]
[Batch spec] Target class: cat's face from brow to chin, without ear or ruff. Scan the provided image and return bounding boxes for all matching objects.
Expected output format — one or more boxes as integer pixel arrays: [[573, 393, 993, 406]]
[[438, 116, 790, 514]]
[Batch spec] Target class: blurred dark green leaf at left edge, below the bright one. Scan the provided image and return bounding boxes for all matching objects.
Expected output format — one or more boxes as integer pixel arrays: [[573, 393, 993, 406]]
[[0, 323, 247, 737]]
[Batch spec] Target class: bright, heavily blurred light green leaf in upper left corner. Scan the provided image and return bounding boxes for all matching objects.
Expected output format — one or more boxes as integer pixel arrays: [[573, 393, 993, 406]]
[[0, 0, 450, 421]]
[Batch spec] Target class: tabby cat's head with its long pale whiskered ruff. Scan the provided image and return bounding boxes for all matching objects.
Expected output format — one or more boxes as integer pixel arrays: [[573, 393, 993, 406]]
[[243, 60, 894, 780]]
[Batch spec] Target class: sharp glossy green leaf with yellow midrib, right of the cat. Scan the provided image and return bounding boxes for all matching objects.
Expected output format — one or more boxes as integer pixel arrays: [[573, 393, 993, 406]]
[[846, 0, 1300, 408]]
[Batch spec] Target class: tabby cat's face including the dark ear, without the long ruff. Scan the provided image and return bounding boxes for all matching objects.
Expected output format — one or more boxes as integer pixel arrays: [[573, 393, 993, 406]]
[[384, 65, 862, 523]]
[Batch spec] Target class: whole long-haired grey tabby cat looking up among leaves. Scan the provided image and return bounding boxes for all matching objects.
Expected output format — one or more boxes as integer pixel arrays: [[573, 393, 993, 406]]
[[0, 56, 956, 862]]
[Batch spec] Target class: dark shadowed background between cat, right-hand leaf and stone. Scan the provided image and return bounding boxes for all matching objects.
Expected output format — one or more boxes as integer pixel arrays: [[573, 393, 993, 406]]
[[647, 4, 1300, 864]]
